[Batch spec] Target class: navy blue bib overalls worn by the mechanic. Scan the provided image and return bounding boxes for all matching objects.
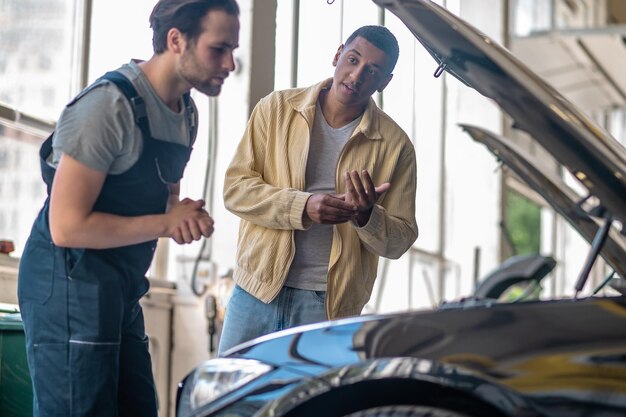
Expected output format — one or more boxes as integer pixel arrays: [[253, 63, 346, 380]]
[[18, 72, 194, 417]]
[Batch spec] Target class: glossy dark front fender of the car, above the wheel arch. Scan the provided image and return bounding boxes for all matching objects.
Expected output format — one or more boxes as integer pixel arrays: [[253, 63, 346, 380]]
[[232, 297, 626, 417]]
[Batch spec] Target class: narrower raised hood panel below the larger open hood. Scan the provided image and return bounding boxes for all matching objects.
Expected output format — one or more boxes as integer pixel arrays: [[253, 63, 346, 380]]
[[461, 125, 626, 277]]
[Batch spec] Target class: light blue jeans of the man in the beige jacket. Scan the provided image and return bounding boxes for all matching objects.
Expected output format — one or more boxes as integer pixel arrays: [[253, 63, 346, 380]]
[[218, 285, 326, 356]]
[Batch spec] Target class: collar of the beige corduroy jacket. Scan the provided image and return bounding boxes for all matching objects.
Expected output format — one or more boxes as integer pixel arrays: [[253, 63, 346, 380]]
[[288, 78, 383, 140]]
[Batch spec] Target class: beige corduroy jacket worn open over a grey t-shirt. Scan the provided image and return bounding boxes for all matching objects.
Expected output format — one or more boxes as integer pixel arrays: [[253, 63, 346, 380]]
[[224, 79, 418, 319]]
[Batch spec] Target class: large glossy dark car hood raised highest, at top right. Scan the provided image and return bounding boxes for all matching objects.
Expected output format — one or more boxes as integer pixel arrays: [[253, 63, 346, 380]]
[[374, 0, 626, 228]]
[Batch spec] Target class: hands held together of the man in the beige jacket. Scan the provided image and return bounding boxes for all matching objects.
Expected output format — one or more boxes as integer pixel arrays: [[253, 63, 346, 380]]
[[305, 170, 391, 226]]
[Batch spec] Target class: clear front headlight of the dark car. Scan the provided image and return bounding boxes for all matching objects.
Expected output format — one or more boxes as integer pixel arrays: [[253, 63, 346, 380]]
[[180, 358, 273, 411]]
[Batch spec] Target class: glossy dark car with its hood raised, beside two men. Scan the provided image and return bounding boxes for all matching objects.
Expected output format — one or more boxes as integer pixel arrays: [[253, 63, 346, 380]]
[[177, 0, 626, 417]]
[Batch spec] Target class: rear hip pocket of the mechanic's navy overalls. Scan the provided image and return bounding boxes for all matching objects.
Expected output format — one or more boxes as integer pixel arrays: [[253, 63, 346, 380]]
[[17, 237, 54, 304]]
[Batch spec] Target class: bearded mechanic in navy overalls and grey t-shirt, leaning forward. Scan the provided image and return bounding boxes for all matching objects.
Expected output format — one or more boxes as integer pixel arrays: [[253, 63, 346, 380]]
[[18, 0, 239, 417]]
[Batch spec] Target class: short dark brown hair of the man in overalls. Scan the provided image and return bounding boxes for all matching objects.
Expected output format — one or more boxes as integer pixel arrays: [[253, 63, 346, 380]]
[[150, 0, 239, 54]]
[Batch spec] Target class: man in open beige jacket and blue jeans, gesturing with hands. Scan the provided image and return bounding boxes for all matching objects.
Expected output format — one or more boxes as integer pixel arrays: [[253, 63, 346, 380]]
[[219, 26, 418, 354]]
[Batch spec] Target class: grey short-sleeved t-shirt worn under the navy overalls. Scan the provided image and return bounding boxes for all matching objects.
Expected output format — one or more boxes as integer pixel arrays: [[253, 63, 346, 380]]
[[48, 61, 197, 174]]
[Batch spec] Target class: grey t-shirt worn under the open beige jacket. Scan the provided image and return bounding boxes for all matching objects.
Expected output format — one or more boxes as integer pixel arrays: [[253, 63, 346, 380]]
[[285, 102, 361, 291]]
